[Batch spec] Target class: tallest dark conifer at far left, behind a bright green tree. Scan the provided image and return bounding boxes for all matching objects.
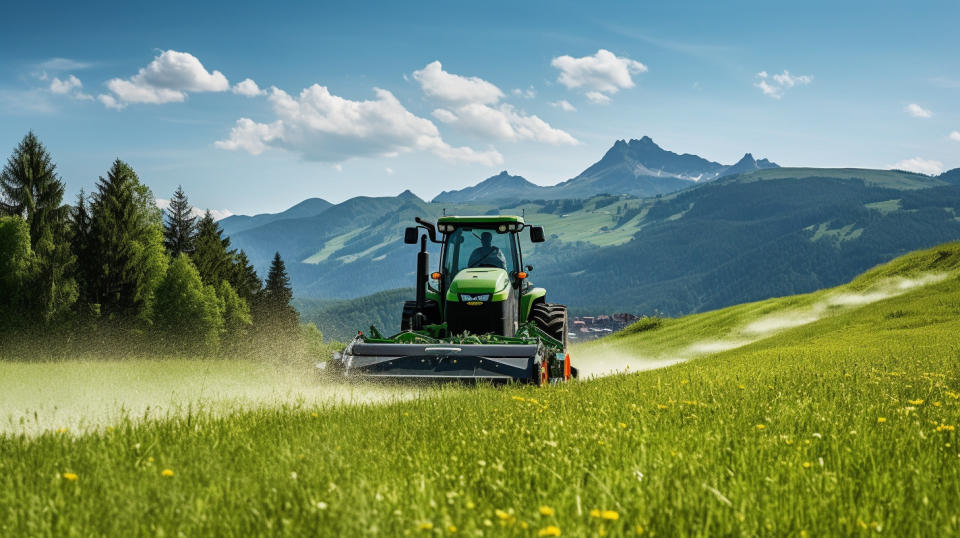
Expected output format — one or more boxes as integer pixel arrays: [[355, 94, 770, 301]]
[[0, 131, 77, 321]]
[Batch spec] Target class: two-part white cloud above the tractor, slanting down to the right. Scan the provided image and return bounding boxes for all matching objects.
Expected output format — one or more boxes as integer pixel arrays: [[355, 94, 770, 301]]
[[413, 61, 577, 144]]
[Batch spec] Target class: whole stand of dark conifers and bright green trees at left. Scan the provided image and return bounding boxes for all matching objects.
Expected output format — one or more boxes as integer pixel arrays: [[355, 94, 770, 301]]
[[0, 132, 320, 355]]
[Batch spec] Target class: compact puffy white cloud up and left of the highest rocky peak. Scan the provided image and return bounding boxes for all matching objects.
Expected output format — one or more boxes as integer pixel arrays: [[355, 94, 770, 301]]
[[550, 49, 647, 102]]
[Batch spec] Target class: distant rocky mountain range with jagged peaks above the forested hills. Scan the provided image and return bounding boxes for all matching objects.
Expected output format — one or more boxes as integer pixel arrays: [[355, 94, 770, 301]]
[[433, 136, 778, 203]]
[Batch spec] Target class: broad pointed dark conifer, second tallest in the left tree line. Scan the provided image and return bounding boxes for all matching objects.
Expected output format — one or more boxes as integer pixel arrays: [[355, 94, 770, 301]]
[[89, 159, 167, 317]]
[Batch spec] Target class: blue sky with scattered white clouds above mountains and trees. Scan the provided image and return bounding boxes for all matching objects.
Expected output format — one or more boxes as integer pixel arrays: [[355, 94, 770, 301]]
[[0, 1, 960, 213]]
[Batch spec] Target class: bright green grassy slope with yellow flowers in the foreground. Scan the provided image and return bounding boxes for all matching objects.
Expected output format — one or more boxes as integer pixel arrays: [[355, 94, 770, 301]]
[[0, 243, 960, 536]]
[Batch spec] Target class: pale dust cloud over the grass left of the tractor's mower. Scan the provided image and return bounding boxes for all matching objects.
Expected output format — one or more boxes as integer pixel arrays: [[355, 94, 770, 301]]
[[0, 360, 420, 435]]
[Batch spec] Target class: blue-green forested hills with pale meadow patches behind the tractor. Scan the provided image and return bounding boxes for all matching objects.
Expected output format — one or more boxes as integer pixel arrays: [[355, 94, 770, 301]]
[[232, 168, 960, 322]]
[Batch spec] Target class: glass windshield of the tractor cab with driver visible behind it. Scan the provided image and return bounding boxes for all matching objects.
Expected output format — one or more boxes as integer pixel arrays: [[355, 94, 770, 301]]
[[443, 228, 518, 278]]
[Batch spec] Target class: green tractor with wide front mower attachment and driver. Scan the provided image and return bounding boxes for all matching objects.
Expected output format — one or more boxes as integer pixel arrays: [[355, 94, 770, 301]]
[[328, 216, 577, 385]]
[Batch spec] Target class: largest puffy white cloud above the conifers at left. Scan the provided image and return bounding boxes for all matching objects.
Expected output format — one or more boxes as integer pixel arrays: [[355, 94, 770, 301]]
[[100, 50, 230, 108]]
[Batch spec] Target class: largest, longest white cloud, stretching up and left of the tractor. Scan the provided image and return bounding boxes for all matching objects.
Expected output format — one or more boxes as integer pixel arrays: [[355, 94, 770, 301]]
[[216, 84, 503, 166]]
